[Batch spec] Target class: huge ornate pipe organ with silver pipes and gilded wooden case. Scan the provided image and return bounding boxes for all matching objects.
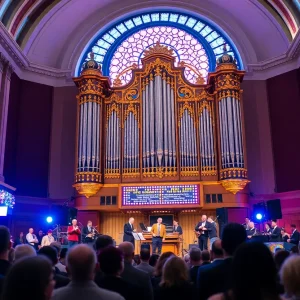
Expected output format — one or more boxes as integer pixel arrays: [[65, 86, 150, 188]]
[[74, 44, 249, 197]]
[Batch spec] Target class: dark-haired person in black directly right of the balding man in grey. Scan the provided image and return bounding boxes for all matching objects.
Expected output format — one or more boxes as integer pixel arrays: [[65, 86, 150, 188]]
[[95, 246, 142, 300]]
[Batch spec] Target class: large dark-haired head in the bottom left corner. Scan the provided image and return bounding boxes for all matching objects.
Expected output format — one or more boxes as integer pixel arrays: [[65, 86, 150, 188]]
[[2, 256, 55, 300]]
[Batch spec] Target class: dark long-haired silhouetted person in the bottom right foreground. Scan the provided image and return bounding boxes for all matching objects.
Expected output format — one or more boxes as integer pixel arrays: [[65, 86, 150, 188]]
[[209, 242, 280, 300]]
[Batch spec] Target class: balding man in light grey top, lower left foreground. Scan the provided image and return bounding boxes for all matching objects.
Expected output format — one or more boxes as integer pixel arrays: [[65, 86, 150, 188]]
[[52, 245, 124, 300]]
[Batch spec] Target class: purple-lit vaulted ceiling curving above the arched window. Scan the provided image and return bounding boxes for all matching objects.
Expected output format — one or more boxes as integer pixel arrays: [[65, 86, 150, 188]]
[[0, 0, 300, 84]]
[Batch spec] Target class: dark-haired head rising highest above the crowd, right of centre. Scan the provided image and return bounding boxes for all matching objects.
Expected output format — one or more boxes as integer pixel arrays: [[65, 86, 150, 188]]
[[222, 223, 247, 256]]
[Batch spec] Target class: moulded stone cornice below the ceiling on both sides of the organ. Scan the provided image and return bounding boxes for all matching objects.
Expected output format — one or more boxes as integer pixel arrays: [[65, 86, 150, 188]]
[[0, 22, 300, 86]]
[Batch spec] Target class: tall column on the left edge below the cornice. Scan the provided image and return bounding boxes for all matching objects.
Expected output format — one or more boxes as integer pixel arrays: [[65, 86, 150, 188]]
[[0, 54, 13, 182]]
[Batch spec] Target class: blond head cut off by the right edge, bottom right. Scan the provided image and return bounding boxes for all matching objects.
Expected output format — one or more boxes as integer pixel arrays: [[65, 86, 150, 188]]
[[280, 255, 300, 299]]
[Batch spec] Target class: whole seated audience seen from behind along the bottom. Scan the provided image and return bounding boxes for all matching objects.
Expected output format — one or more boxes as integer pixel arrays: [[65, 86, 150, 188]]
[[0, 223, 300, 300]]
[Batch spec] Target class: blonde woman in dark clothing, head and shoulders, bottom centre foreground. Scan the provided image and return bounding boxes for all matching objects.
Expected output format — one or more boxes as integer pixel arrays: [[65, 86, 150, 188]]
[[154, 256, 196, 300]]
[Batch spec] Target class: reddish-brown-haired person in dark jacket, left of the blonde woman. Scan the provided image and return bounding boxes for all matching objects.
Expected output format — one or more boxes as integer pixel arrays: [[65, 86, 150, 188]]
[[119, 242, 153, 300]]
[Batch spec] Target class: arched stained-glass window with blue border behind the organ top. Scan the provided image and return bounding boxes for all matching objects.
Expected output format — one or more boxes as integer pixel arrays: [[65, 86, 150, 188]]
[[76, 11, 242, 85]]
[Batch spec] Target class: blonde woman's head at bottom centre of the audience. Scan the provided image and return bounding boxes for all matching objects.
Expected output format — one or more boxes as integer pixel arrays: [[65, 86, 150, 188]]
[[160, 256, 189, 287]]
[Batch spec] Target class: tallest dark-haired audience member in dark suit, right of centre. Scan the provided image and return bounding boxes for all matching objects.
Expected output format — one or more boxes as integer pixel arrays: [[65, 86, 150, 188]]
[[197, 223, 247, 300]]
